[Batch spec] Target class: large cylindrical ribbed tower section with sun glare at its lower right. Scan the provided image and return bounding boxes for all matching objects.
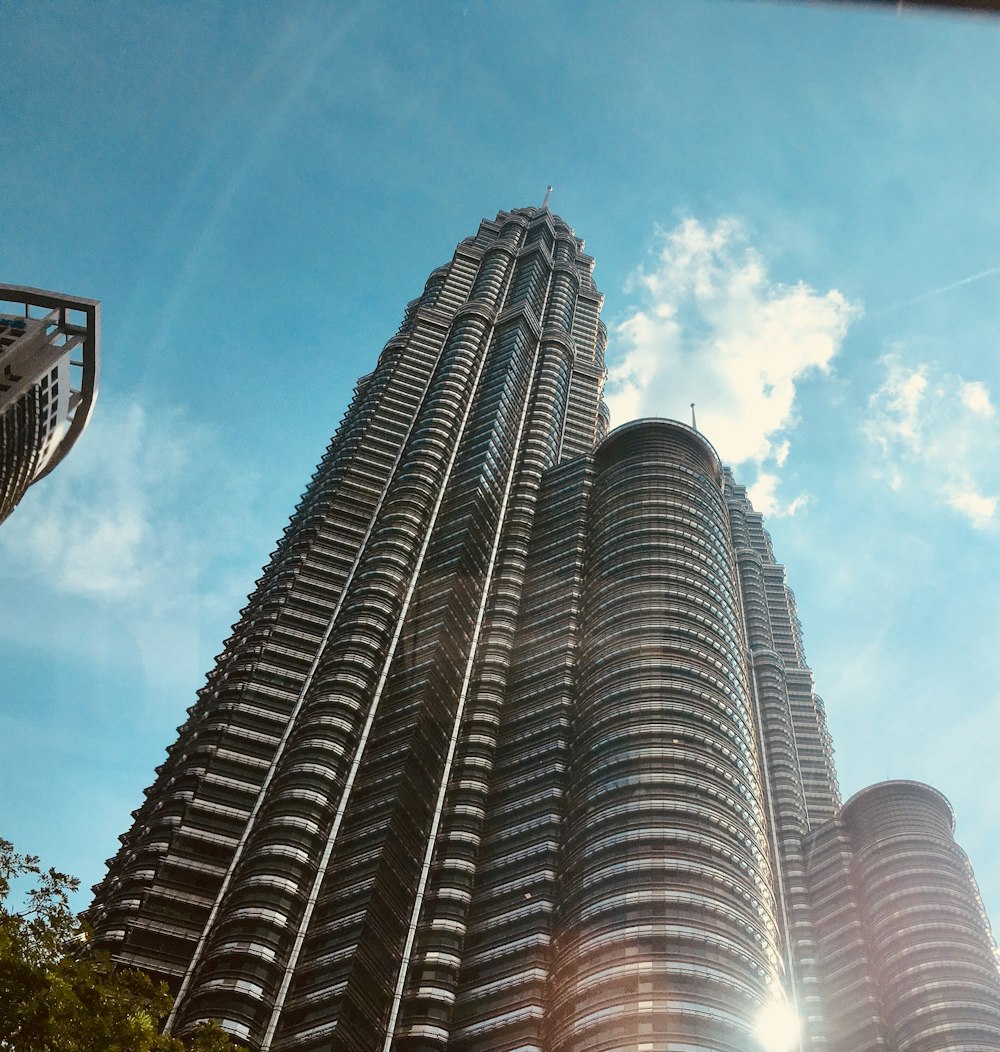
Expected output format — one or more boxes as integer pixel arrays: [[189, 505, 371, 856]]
[[551, 421, 780, 1052]]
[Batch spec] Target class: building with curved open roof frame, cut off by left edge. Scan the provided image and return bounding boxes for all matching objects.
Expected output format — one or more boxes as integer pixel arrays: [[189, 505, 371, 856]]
[[0, 285, 101, 522]]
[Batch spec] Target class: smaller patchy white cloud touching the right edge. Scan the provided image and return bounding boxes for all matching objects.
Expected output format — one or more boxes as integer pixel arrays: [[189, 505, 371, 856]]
[[864, 351, 1000, 529]]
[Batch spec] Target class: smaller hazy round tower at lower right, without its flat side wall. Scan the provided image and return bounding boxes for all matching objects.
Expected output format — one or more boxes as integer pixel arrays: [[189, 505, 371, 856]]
[[842, 782, 1000, 1052]]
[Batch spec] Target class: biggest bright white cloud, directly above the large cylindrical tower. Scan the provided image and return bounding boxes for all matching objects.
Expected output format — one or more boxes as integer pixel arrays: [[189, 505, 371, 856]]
[[608, 218, 860, 514]]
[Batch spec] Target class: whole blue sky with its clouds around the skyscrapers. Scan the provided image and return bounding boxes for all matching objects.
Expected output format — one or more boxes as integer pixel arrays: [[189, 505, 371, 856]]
[[0, 0, 1000, 938]]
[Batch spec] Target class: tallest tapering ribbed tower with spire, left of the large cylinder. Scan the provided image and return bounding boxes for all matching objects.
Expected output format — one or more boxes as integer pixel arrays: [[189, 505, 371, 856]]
[[91, 209, 607, 1049]]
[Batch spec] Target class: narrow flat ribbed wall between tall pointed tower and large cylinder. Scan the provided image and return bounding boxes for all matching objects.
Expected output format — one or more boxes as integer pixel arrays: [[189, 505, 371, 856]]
[[438, 457, 593, 1052]]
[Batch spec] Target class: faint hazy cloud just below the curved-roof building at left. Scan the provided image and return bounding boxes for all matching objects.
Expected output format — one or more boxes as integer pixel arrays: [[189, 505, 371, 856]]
[[0, 399, 259, 603]]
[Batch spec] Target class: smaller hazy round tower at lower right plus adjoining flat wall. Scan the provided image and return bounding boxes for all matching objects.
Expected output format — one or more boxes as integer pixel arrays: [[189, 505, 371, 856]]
[[810, 782, 1000, 1052]]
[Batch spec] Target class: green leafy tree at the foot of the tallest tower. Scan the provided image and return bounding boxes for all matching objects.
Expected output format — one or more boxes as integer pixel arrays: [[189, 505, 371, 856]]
[[0, 838, 239, 1052]]
